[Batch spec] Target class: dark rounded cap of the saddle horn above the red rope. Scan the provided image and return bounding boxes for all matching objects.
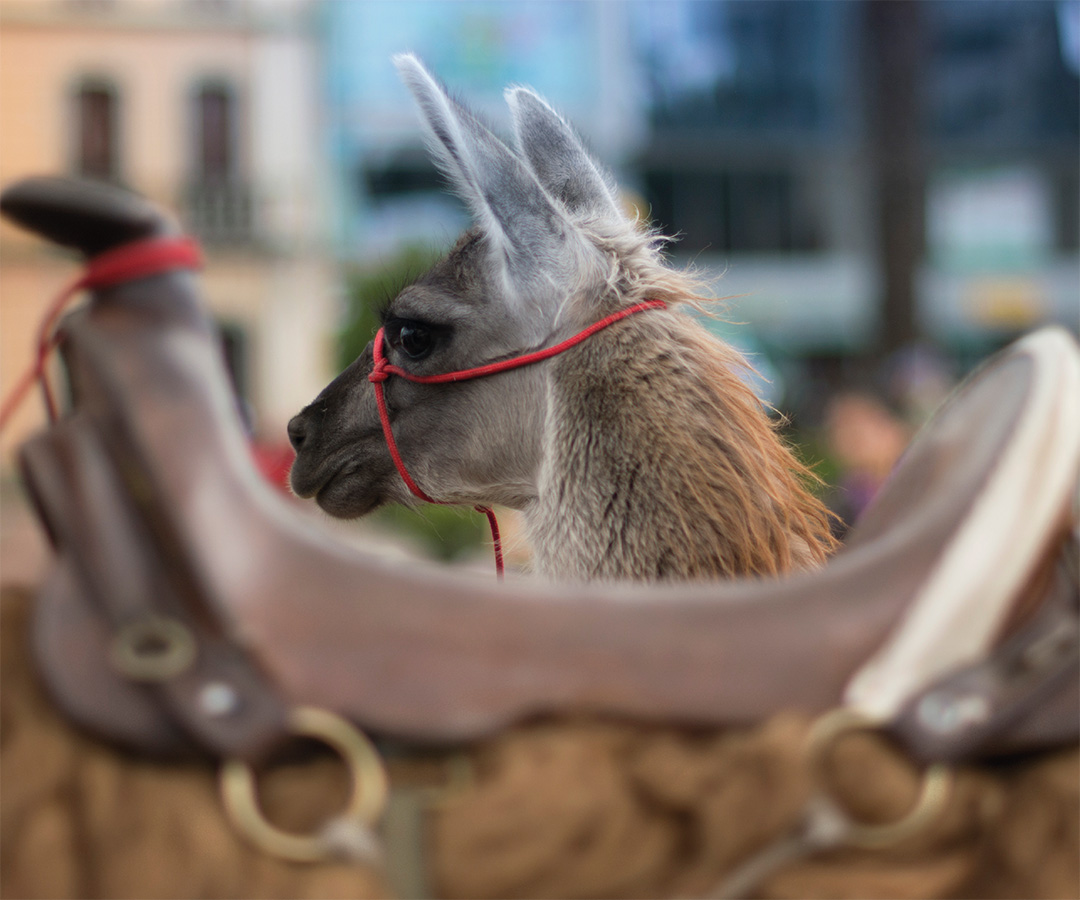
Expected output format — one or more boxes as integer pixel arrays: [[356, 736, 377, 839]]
[[0, 176, 179, 257]]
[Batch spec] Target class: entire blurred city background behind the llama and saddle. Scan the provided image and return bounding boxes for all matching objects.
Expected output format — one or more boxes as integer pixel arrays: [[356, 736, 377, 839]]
[[0, 0, 1080, 561]]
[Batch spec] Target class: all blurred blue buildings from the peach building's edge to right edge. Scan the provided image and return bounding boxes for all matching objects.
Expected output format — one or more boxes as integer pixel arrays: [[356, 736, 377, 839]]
[[322, 0, 1080, 365]]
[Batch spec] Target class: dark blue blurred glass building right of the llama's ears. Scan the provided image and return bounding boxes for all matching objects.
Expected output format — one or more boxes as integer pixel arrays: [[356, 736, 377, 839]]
[[636, 0, 1080, 353]]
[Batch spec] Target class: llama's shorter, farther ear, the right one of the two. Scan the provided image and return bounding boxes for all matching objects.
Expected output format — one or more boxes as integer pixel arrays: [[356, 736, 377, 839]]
[[505, 88, 623, 219]]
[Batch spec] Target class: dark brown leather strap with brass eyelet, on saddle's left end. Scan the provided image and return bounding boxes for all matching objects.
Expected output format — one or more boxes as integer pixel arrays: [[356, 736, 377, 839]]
[[22, 414, 286, 761]]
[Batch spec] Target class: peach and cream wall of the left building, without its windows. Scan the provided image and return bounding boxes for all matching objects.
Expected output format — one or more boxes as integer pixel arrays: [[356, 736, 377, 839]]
[[0, 0, 334, 455]]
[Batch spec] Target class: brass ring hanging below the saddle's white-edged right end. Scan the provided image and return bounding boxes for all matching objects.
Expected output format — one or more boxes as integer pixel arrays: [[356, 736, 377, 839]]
[[805, 707, 953, 849]]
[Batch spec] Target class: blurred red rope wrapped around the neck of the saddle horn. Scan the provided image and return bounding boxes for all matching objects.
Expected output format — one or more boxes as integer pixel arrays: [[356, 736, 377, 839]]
[[0, 237, 202, 430]]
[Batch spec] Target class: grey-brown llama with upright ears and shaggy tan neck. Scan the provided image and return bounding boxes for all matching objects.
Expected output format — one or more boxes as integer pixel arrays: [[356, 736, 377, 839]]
[[288, 55, 833, 580]]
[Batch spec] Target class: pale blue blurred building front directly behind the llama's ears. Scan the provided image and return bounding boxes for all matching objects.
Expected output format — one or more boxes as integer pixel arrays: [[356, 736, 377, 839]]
[[321, 0, 645, 260]]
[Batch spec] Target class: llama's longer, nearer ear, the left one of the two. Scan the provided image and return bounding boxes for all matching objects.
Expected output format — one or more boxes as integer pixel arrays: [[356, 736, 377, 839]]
[[394, 53, 573, 304]]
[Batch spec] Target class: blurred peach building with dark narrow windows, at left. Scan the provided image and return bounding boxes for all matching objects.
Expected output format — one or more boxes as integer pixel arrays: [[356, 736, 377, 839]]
[[0, 0, 334, 446]]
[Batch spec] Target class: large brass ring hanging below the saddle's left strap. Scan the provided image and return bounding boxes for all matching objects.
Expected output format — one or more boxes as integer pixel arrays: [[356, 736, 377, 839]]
[[220, 707, 389, 862]]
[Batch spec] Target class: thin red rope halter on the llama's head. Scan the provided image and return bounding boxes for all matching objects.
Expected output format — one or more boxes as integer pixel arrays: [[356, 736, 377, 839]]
[[367, 300, 667, 579]]
